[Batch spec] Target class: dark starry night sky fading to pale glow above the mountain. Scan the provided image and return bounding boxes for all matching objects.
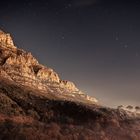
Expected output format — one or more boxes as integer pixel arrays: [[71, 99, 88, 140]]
[[0, 0, 140, 107]]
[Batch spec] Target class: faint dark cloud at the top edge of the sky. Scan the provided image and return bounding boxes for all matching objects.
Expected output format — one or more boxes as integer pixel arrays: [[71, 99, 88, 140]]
[[73, 0, 100, 7]]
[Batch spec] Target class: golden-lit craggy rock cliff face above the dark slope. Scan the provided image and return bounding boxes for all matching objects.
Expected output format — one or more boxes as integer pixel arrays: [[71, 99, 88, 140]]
[[0, 31, 97, 103]]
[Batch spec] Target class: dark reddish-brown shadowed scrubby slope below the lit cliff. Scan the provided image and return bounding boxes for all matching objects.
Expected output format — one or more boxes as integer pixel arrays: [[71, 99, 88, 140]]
[[0, 79, 140, 140]]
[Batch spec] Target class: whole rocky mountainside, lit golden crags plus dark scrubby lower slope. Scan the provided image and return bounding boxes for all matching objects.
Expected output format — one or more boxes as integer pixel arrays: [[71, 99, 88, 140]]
[[0, 31, 140, 140]]
